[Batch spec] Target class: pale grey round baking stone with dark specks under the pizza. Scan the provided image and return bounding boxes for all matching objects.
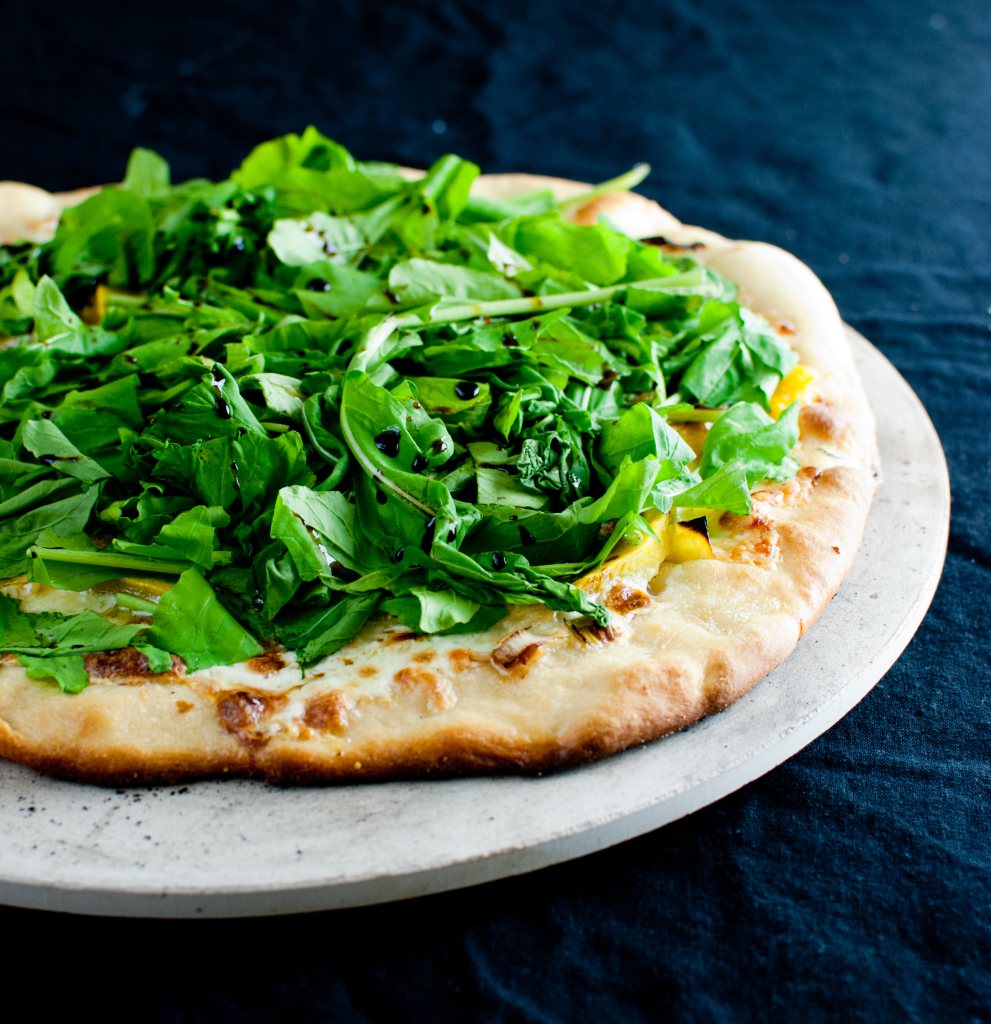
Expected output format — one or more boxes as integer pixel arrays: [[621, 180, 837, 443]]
[[0, 332, 949, 916]]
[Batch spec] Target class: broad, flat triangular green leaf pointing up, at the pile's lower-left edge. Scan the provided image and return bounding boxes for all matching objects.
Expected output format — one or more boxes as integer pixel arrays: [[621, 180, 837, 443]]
[[147, 569, 262, 672]]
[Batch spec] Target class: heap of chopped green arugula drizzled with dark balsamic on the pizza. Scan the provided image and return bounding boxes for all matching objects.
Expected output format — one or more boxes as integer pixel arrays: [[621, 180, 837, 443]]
[[0, 128, 798, 690]]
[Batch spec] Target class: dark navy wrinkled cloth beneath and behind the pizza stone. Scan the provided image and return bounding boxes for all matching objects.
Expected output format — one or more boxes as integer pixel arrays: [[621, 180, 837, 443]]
[[0, 0, 991, 1024]]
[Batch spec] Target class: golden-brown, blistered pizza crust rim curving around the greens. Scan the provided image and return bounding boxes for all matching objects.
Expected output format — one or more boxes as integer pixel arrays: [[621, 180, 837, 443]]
[[0, 174, 879, 784]]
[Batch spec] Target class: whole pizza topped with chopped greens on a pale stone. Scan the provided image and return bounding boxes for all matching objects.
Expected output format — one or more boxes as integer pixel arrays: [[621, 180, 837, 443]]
[[0, 128, 879, 784]]
